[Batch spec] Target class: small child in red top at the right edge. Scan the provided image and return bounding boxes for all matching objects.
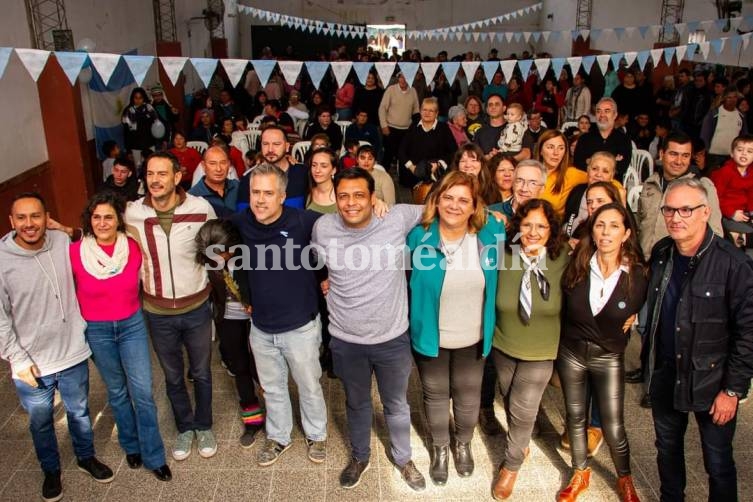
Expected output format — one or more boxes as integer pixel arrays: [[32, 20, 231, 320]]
[[711, 134, 753, 248]]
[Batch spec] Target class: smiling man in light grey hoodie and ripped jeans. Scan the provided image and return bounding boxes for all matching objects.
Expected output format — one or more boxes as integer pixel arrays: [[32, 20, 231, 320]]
[[0, 193, 113, 501]]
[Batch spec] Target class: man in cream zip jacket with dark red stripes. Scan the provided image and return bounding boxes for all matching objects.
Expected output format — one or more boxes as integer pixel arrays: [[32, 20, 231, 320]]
[[125, 153, 217, 460]]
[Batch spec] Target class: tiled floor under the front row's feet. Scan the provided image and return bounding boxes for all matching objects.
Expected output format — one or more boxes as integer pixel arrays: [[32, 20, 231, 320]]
[[0, 334, 753, 502]]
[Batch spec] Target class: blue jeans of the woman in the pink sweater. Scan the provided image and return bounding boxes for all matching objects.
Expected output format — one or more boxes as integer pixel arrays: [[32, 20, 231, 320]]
[[86, 309, 165, 469]]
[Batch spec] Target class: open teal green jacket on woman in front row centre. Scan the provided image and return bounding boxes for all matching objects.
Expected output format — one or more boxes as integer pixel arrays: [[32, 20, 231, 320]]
[[408, 217, 505, 357]]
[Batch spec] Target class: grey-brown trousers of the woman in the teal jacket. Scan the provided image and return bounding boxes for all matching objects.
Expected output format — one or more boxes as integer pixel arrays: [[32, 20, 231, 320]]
[[415, 344, 486, 446]]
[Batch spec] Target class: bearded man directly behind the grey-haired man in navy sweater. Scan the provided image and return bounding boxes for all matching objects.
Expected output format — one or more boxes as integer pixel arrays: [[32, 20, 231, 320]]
[[238, 126, 308, 211]]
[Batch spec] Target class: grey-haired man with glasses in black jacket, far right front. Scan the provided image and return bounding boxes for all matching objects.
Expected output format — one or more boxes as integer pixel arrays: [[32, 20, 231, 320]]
[[644, 178, 753, 500]]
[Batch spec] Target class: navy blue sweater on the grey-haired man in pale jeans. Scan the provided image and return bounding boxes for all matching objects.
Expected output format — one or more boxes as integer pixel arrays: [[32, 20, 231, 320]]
[[230, 206, 321, 334]]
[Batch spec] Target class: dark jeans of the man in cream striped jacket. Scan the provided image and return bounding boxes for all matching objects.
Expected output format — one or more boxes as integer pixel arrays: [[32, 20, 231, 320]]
[[144, 302, 212, 433]]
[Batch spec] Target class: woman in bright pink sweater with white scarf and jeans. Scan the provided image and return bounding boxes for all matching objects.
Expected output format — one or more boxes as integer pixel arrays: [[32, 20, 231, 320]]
[[70, 191, 172, 481]]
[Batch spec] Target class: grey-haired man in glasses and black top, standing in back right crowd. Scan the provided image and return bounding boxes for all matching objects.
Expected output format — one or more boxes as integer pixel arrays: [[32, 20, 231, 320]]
[[573, 98, 633, 181]]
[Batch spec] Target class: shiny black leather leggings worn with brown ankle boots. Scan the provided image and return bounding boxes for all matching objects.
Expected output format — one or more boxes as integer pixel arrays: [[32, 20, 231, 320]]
[[556, 340, 630, 476]]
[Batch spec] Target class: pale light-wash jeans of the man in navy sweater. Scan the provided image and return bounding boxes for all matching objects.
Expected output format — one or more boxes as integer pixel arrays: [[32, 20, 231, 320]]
[[250, 316, 327, 445]]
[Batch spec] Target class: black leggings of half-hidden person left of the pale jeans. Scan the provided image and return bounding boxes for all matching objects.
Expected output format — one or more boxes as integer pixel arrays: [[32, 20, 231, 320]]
[[217, 319, 261, 408]]
